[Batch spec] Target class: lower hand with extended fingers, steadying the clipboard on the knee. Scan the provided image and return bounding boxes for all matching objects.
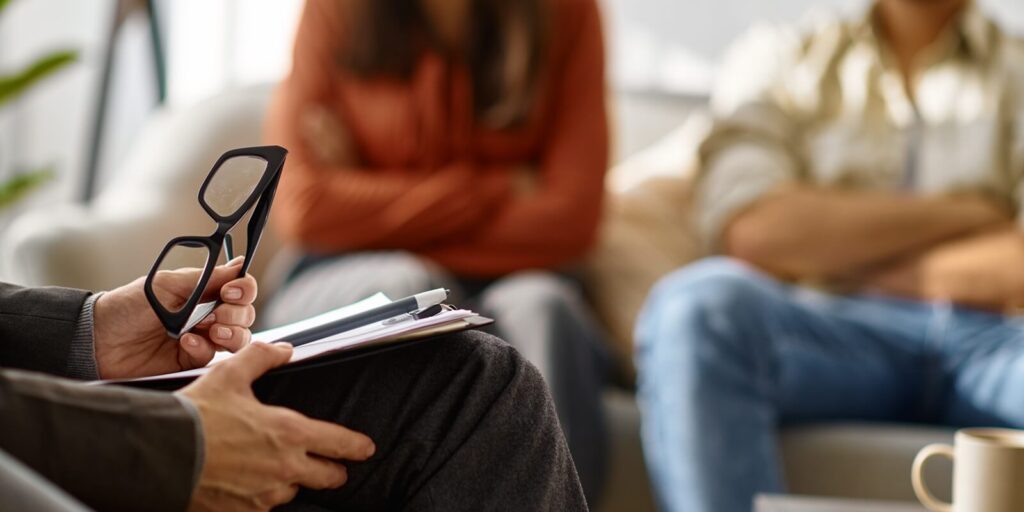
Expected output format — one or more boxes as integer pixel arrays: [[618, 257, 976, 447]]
[[179, 343, 376, 511]]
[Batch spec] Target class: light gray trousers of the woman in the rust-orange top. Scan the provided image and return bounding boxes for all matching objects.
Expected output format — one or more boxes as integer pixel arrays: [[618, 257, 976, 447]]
[[262, 252, 609, 506]]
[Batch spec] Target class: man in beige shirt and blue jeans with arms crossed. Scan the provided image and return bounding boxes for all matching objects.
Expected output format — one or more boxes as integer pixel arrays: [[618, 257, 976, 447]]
[[637, 0, 1024, 512]]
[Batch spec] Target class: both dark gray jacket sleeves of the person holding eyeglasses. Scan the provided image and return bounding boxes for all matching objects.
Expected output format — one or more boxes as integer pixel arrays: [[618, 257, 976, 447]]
[[0, 284, 202, 511]]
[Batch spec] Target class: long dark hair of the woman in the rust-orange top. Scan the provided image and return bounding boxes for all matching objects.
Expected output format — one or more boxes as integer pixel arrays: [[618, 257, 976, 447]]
[[340, 0, 549, 128]]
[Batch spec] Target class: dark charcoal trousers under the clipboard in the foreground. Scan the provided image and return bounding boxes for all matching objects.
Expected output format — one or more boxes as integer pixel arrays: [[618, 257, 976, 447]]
[[255, 332, 587, 512]]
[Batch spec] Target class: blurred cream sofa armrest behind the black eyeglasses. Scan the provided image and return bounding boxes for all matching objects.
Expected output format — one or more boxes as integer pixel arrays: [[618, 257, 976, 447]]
[[0, 86, 282, 296]]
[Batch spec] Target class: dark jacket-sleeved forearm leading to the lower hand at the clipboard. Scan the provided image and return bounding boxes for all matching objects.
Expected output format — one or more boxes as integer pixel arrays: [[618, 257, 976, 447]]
[[0, 371, 202, 511]]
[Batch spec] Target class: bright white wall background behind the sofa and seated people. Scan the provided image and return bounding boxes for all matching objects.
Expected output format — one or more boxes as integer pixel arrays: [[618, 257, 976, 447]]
[[0, 0, 1024, 222]]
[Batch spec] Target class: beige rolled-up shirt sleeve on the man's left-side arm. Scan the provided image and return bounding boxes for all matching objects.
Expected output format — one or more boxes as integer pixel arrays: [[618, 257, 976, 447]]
[[694, 28, 802, 252]]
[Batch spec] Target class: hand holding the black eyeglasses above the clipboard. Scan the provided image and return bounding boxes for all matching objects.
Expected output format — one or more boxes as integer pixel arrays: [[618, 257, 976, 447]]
[[93, 257, 257, 379]]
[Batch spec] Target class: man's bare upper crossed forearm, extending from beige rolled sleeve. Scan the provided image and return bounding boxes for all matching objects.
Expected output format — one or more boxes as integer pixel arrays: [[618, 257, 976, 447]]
[[724, 187, 1007, 279]]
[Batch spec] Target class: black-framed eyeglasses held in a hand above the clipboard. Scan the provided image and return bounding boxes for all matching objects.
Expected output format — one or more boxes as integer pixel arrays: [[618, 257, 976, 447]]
[[144, 145, 288, 339]]
